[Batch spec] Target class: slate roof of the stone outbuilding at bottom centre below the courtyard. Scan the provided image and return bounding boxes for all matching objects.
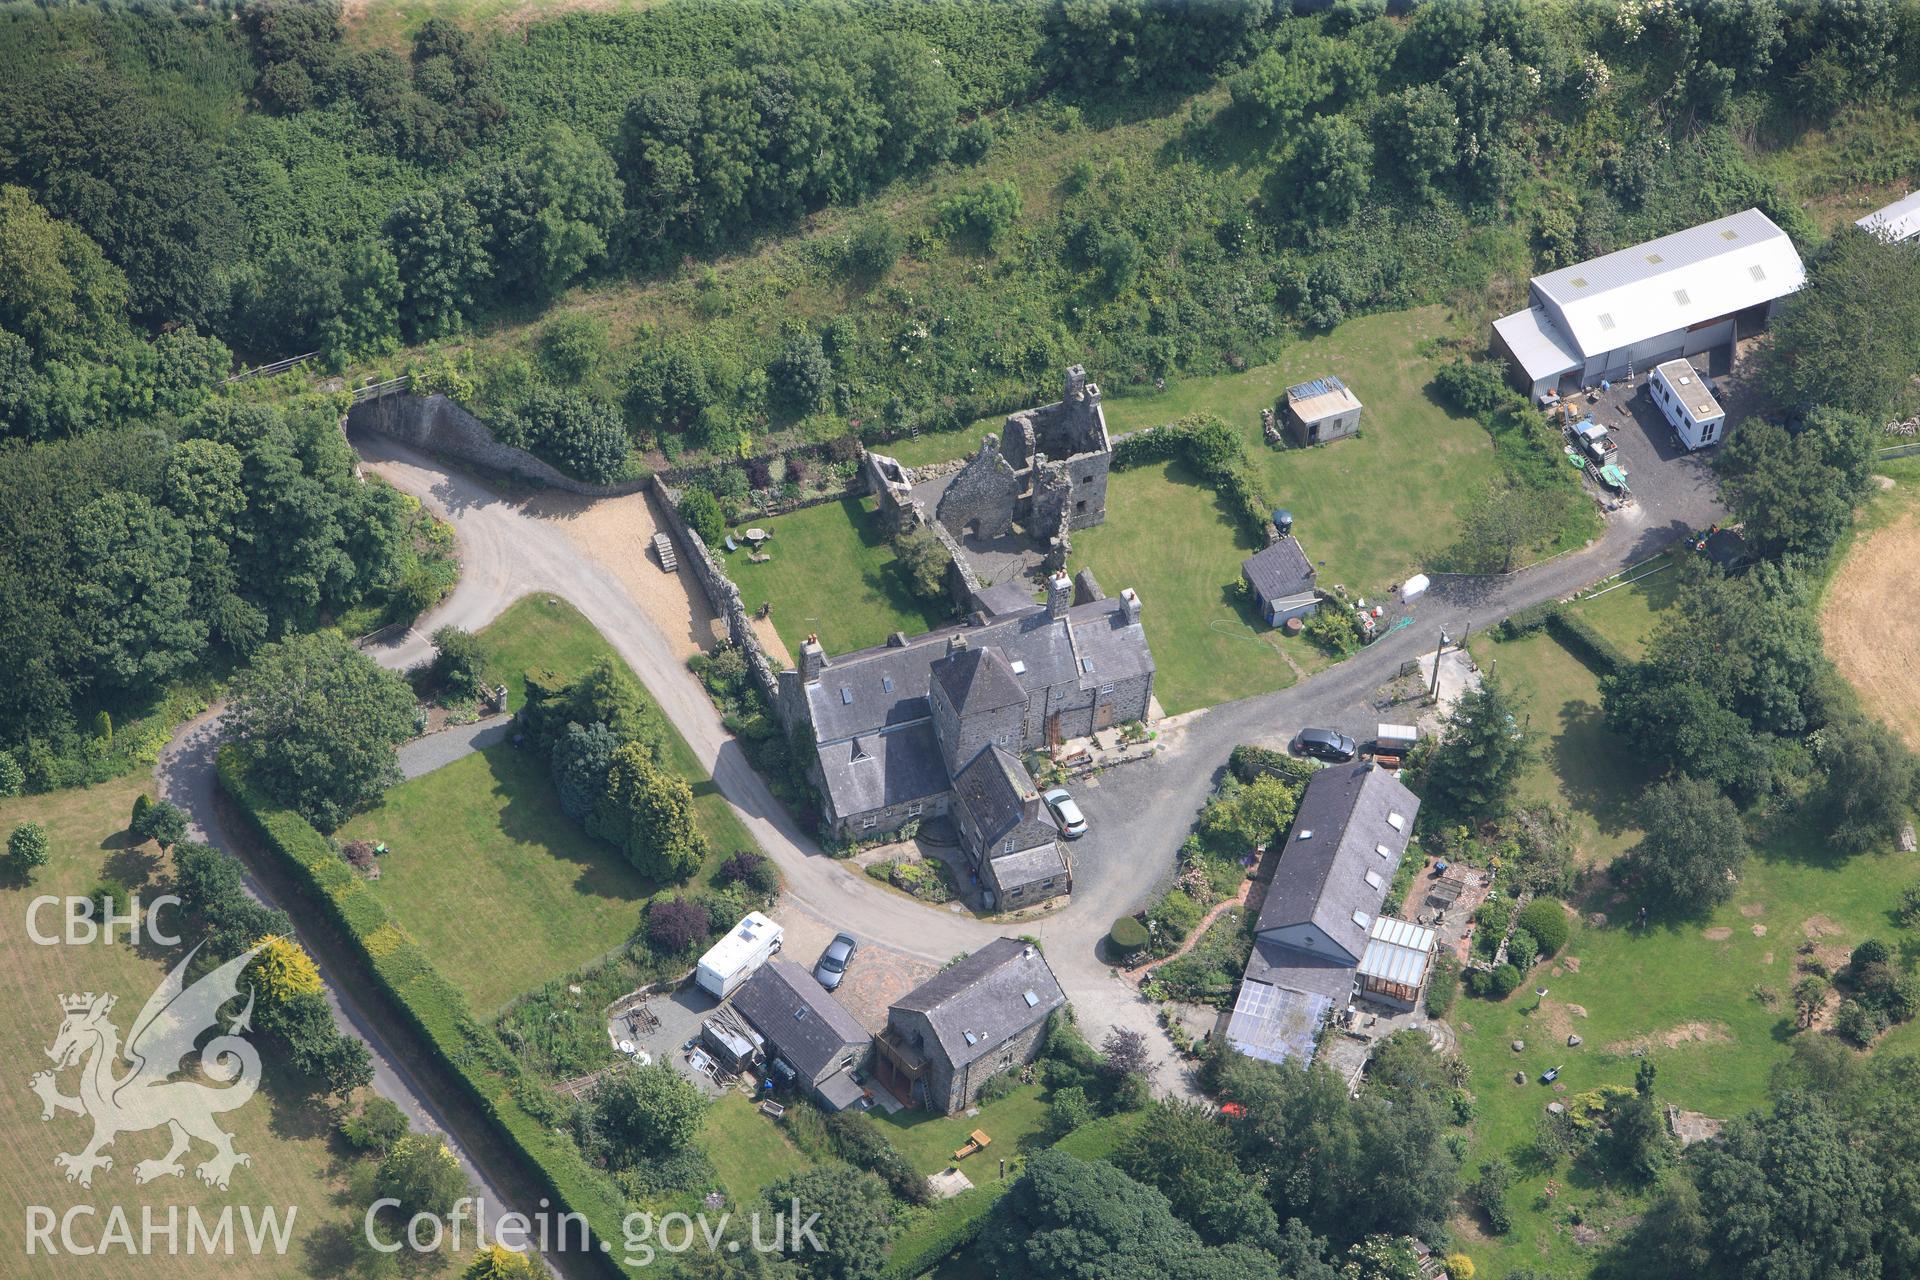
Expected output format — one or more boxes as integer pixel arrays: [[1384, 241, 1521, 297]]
[[893, 938, 1068, 1067]]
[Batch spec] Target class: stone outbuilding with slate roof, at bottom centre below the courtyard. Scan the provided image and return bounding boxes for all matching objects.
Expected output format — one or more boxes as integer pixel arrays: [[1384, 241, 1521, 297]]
[[874, 938, 1068, 1115]]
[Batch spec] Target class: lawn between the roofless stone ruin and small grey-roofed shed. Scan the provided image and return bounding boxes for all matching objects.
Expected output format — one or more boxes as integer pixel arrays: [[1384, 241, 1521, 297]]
[[1068, 461, 1329, 714]]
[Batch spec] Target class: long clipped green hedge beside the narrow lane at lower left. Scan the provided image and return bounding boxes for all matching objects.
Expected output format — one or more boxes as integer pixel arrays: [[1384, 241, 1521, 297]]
[[219, 747, 639, 1274]]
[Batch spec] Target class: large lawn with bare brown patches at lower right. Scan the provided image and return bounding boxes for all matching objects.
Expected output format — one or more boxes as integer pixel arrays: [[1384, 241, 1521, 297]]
[[1452, 827, 1920, 1278]]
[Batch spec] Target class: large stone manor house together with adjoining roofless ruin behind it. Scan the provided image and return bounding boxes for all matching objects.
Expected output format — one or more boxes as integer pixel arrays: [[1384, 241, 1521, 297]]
[[778, 367, 1154, 910]]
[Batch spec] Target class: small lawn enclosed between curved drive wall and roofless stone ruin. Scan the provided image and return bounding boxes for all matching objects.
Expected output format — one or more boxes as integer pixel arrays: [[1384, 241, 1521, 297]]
[[724, 497, 952, 654]]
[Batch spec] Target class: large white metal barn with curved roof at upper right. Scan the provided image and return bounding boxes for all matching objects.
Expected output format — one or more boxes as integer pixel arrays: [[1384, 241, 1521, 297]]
[[1494, 209, 1807, 399]]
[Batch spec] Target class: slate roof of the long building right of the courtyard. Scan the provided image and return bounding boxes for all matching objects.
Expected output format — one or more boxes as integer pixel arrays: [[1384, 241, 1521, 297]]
[[1256, 764, 1421, 958]]
